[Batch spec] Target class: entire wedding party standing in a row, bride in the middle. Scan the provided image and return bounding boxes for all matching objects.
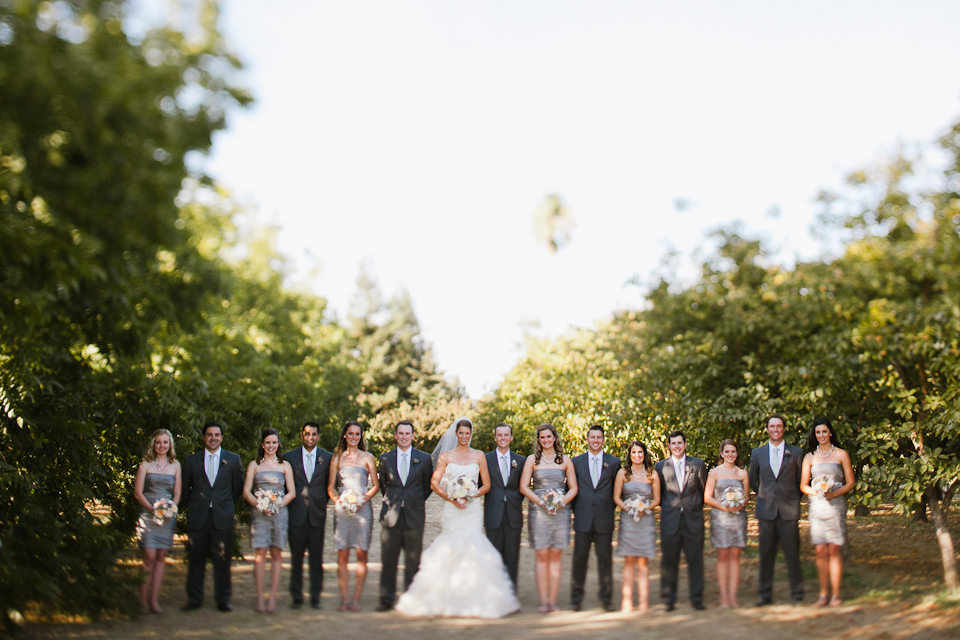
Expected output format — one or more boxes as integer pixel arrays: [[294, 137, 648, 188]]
[[134, 415, 855, 618]]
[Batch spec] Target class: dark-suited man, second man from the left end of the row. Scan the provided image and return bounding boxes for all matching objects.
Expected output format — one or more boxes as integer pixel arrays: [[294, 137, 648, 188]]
[[283, 422, 333, 609]]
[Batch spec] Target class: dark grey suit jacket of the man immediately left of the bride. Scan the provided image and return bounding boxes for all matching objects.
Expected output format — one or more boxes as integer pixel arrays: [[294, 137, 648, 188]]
[[377, 447, 433, 531]]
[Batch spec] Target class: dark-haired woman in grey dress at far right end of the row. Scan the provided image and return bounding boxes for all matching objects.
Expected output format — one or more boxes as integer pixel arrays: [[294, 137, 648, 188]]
[[800, 418, 855, 607]]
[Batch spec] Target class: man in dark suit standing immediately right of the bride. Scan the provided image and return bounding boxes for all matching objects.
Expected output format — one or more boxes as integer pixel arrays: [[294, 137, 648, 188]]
[[483, 422, 526, 591]]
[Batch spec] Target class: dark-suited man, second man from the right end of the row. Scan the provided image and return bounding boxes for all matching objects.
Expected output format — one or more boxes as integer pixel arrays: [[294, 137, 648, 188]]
[[654, 431, 707, 611]]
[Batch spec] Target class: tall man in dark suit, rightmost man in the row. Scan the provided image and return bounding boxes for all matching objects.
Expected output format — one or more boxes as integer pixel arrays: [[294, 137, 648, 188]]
[[750, 416, 803, 607]]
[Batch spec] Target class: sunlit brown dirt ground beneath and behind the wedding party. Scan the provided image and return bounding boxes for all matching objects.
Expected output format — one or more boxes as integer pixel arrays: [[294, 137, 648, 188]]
[[27, 497, 960, 640]]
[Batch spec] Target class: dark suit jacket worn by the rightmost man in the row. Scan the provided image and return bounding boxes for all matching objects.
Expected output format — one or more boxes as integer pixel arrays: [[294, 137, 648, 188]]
[[750, 442, 803, 520]]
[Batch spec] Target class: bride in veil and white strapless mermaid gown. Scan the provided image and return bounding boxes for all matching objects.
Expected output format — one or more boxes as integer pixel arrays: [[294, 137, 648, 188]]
[[396, 418, 520, 618]]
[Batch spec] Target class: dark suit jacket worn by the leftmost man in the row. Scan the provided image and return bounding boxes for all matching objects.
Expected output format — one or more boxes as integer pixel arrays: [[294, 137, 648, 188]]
[[180, 448, 243, 530]]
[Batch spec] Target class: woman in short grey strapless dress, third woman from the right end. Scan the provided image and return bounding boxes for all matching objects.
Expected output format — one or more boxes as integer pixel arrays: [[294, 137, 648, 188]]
[[613, 440, 660, 612]]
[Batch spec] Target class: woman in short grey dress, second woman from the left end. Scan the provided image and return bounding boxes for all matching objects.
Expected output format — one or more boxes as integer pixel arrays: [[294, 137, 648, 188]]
[[243, 429, 296, 613]]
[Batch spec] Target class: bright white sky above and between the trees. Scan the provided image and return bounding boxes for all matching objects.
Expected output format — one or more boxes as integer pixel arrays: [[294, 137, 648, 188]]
[[207, 0, 960, 398]]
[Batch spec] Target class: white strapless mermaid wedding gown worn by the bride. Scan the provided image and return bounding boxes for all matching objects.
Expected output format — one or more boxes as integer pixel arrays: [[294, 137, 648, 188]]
[[397, 463, 520, 618]]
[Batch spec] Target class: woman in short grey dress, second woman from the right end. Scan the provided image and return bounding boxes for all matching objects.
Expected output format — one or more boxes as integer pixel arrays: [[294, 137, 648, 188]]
[[703, 440, 750, 609]]
